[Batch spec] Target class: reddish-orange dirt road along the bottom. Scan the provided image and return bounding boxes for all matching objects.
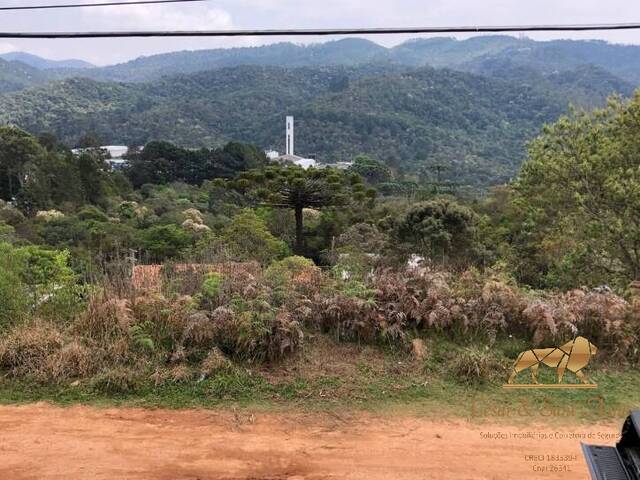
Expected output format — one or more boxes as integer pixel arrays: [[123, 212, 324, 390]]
[[0, 404, 619, 480]]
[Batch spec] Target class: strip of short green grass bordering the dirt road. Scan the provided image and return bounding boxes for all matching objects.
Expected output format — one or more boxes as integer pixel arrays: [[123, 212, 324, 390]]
[[0, 335, 640, 421]]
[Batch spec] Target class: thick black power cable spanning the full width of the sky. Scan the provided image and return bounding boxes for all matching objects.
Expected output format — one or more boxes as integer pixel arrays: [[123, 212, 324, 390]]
[[0, 22, 640, 38]]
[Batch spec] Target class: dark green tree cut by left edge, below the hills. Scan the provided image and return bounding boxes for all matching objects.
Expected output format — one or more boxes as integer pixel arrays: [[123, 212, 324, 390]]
[[0, 127, 45, 200]]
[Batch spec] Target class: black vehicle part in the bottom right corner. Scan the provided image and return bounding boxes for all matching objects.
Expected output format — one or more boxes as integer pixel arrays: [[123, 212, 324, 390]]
[[582, 410, 640, 480]]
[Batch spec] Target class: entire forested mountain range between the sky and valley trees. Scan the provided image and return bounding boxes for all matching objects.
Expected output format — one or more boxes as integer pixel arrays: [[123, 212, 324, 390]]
[[0, 36, 640, 187]]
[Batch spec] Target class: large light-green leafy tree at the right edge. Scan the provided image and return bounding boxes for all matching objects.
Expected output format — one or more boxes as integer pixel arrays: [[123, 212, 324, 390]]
[[514, 93, 640, 286]]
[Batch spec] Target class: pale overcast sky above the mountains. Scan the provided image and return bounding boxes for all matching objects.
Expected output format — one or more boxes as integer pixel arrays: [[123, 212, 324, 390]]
[[0, 0, 640, 65]]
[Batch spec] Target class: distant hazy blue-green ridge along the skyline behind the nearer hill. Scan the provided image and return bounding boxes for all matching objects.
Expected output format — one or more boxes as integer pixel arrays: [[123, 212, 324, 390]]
[[60, 35, 640, 85]]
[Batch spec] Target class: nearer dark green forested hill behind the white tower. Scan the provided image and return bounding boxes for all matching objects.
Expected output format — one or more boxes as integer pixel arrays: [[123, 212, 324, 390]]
[[0, 62, 631, 184]]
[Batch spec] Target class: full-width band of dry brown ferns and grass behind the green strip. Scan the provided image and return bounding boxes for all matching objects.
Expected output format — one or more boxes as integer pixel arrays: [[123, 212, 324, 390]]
[[0, 259, 640, 392]]
